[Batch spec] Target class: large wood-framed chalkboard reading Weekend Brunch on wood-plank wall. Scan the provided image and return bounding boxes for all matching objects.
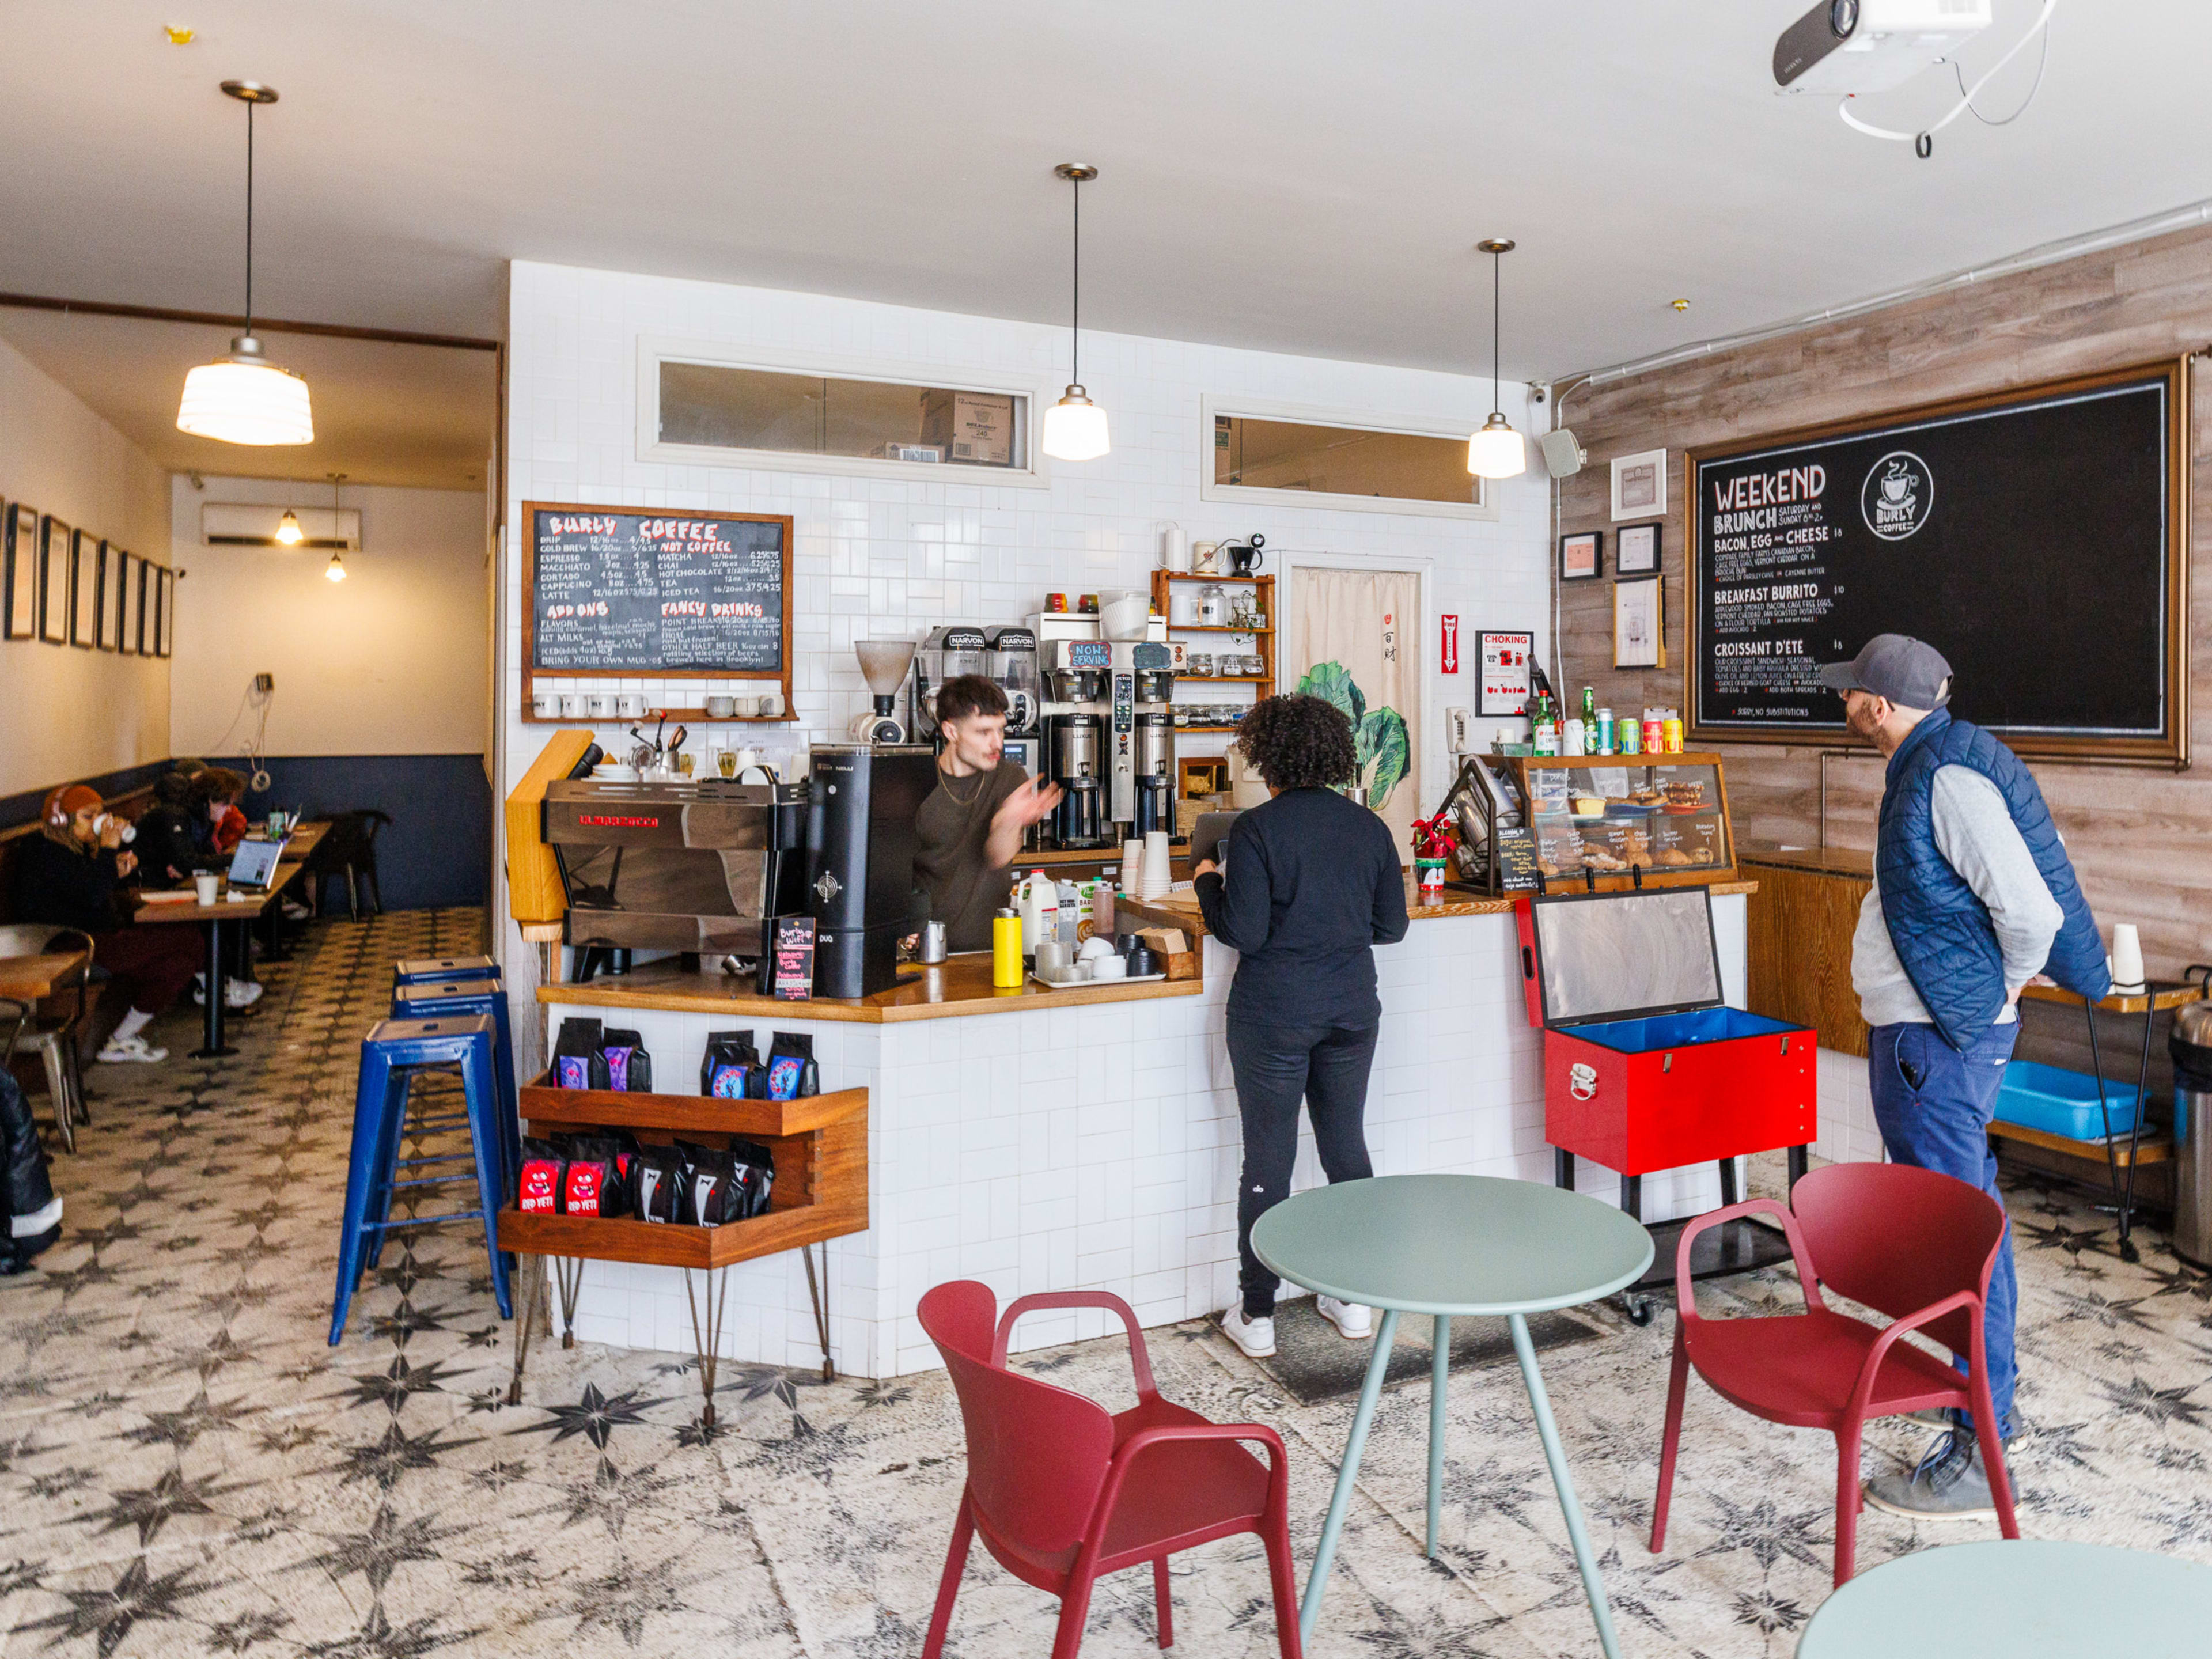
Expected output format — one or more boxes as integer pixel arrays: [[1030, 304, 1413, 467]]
[[1683, 363, 2188, 763]]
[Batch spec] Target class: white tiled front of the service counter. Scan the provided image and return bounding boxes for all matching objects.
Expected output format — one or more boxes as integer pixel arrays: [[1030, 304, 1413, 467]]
[[540, 893, 1745, 1378]]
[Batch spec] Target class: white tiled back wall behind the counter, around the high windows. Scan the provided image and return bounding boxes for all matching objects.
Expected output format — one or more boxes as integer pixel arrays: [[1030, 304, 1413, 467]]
[[500, 261, 1551, 988]]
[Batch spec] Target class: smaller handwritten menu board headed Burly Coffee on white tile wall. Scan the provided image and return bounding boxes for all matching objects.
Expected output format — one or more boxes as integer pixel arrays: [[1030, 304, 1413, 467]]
[[527, 502, 790, 675]]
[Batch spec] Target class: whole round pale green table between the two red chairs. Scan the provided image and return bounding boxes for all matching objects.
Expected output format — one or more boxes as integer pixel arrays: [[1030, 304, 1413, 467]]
[[1252, 1175, 1652, 1659]]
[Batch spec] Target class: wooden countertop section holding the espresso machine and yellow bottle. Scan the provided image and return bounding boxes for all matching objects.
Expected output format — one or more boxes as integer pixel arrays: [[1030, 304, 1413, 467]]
[[537, 951, 1206, 1024]]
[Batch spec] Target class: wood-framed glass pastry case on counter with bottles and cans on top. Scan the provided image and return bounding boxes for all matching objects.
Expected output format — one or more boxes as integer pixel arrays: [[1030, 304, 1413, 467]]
[[1500, 754, 1736, 892]]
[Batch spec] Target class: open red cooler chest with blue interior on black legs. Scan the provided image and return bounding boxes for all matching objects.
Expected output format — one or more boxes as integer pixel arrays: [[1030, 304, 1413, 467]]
[[1515, 887, 1818, 1212]]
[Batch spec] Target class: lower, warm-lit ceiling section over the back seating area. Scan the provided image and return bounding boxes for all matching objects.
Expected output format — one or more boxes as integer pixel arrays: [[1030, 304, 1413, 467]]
[[0, 305, 500, 489]]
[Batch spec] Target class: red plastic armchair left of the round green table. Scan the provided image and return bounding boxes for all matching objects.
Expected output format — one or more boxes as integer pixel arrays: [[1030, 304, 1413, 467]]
[[920, 1279, 1298, 1659]]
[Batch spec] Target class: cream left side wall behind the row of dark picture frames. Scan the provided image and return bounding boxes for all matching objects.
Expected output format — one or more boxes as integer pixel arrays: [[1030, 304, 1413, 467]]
[[0, 343, 171, 796]]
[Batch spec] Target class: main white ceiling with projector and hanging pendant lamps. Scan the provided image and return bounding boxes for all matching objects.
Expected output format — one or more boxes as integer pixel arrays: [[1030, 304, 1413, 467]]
[[0, 0, 2212, 382]]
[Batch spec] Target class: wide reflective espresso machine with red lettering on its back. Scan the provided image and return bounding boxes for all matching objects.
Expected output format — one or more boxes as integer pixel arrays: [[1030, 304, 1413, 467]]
[[540, 779, 808, 956]]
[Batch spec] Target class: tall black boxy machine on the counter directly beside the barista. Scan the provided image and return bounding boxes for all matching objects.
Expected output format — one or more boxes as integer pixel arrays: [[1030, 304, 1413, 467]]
[[805, 743, 938, 998]]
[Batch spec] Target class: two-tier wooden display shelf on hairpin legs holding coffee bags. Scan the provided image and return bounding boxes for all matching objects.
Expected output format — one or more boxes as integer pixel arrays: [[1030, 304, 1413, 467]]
[[498, 1073, 869, 1429]]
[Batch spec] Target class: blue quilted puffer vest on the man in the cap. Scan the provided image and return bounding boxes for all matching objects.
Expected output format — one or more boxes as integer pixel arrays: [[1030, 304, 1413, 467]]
[[1873, 708, 2112, 1051]]
